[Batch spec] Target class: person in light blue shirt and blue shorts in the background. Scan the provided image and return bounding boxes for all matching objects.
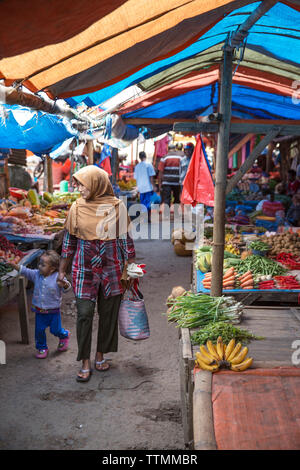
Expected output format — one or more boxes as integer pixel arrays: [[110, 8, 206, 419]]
[[134, 152, 155, 220]]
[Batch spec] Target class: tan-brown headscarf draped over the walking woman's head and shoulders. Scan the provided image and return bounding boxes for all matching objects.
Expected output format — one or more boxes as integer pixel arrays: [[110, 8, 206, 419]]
[[65, 165, 130, 240]]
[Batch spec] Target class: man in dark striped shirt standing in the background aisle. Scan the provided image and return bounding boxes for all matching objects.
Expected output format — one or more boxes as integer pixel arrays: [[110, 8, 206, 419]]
[[158, 144, 183, 211]]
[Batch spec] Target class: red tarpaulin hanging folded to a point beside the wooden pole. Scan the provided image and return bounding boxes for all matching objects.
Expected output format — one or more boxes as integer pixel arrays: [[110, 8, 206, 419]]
[[181, 134, 215, 206]]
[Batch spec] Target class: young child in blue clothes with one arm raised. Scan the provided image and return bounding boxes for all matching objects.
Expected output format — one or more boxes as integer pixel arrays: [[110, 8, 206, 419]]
[[10, 250, 71, 359]]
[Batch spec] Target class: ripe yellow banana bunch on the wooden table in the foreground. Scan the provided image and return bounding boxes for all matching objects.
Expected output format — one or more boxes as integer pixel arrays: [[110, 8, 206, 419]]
[[195, 336, 253, 372]]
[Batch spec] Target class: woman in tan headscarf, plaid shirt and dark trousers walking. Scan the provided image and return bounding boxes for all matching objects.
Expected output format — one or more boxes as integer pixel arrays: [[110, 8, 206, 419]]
[[58, 165, 135, 382]]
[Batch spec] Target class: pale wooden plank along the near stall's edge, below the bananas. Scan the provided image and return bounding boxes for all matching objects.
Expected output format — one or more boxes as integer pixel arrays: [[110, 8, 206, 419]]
[[193, 370, 217, 450]]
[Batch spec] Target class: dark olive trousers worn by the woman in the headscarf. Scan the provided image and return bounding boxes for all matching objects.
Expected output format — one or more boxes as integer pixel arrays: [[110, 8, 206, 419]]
[[76, 286, 122, 361]]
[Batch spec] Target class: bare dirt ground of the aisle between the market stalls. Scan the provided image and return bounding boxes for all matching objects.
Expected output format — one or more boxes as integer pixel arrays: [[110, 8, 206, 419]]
[[0, 225, 191, 450]]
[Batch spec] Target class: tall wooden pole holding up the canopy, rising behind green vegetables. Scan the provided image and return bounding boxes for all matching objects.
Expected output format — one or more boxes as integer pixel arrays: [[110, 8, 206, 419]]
[[210, 45, 233, 297]]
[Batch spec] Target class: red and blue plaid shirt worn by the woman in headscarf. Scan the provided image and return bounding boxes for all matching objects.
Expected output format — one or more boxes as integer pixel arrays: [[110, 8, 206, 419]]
[[61, 230, 135, 301]]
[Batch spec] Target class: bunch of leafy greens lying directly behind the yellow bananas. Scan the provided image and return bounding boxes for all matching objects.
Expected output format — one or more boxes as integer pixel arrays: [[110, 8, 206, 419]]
[[191, 321, 264, 345]]
